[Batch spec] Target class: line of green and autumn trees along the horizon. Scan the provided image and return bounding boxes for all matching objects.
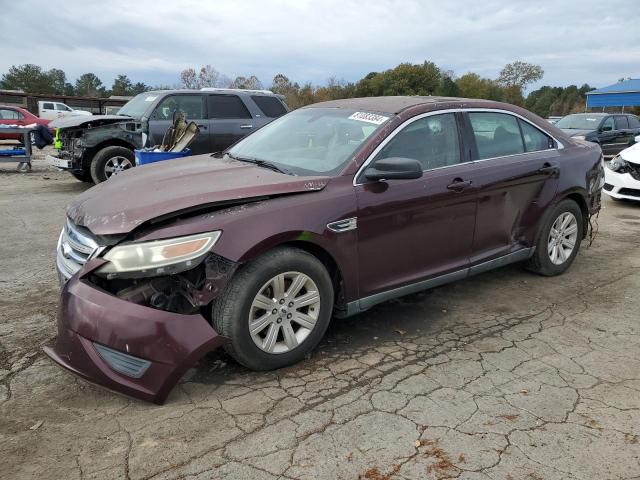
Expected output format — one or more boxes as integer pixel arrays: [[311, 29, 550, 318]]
[[0, 61, 592, 117]]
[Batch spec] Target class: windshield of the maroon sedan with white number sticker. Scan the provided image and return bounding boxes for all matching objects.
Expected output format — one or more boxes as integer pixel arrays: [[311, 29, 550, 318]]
[[228, 108, 389, 175]]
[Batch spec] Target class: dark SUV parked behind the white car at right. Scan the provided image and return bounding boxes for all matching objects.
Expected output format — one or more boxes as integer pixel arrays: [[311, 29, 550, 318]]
[[555, 113, 640, 157]]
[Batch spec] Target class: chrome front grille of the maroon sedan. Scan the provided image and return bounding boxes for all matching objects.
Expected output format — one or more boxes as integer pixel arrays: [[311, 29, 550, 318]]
[[56, 219, 100, 280]]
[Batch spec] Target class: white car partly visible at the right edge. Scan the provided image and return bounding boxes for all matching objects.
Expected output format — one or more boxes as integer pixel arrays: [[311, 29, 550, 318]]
[[603, 135, 640, 200]]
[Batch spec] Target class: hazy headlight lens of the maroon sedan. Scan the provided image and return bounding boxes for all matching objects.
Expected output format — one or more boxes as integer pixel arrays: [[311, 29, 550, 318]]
[[97, 230, 222, 276]]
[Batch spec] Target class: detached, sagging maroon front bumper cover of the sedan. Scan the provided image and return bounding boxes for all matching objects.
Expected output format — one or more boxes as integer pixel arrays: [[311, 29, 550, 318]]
[[45, 275, 225, 403]]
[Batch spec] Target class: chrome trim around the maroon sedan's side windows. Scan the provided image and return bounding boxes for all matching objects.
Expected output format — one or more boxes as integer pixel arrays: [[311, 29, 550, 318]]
[[352, 108, 565, 187]]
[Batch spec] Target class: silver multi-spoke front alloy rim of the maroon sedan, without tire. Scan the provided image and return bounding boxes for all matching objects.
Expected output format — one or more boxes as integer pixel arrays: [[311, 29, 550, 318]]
[[249, 272, 320, 354]]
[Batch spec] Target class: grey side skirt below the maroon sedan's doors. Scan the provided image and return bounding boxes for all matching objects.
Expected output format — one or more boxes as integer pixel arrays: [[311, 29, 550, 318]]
[[335, 247, 535, 318]]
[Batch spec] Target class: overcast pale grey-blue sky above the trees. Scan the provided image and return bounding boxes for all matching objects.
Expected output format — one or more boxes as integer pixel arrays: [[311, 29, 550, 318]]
[[0, 0, 640, 87]]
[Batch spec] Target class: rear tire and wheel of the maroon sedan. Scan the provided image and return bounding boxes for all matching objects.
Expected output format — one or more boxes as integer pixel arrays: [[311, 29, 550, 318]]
[[526, 199, 584, 277]]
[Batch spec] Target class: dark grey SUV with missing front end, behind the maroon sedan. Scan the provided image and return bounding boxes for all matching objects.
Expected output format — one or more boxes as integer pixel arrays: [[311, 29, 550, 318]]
[[47, 88, 288, 183]]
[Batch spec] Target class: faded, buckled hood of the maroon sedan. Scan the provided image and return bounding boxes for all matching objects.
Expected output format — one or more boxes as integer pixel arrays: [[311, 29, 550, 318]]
[[67, 155, 330, 235]]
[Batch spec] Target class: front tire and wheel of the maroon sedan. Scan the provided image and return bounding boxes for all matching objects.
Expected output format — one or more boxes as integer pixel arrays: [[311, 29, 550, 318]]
[[211, 247, 334, 370]]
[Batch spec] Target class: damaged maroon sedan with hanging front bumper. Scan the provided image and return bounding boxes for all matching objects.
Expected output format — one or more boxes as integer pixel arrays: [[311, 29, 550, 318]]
[[46, 97, 603, 402]]
